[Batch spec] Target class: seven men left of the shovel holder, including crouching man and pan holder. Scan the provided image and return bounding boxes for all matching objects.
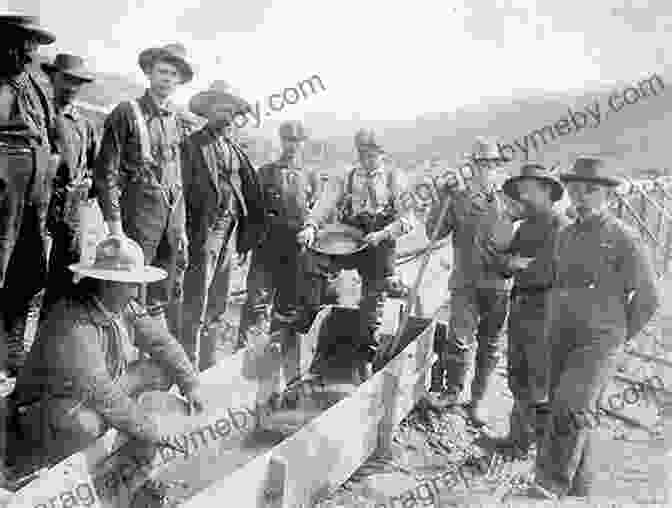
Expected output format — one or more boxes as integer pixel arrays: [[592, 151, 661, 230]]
[[0, 11, 412, 478]]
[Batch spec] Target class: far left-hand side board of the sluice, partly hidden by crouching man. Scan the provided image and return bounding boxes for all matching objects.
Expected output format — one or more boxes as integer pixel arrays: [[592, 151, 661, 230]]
[[9, 307, 331, 507]]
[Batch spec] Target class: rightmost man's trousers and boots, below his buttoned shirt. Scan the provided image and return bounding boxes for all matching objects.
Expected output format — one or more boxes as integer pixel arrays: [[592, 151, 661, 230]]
[[536, 289, 626, 495]]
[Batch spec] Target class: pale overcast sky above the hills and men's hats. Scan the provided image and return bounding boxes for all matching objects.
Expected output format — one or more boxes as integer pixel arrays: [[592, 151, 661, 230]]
[[0, 0, 672, 120]]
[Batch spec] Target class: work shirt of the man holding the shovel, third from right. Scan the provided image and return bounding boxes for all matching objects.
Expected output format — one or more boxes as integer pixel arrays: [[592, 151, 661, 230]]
[[426, 184, 519, 290]]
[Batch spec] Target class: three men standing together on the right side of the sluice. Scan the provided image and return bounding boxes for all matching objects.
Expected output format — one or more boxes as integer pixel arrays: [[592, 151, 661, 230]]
[[427, 141, 660, 499]]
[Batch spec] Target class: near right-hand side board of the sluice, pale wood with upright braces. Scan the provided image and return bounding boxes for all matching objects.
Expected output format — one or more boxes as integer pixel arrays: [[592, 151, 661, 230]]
[[183, 320, 436, 508]]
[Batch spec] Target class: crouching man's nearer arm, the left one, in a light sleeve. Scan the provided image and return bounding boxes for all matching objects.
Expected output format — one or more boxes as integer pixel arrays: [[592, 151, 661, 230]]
[[58, 324, 161, 443]]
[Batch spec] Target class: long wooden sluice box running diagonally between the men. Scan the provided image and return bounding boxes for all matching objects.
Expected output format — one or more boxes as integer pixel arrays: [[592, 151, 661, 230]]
[[8, 307, 436, 508]]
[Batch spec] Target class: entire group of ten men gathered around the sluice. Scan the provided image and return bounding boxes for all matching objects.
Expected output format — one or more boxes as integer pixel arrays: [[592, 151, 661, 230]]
[[0, 9, 659, 497]]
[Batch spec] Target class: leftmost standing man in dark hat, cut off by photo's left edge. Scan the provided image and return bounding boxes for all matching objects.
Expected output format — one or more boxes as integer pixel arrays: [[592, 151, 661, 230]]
[[0, 10, 58, 483]]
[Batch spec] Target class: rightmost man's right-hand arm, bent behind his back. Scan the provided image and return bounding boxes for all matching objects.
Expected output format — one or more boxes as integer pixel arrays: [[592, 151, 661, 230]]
[[622, 232, 661, 340]]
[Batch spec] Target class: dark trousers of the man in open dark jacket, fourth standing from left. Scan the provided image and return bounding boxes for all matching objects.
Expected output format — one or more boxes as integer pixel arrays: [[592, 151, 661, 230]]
[[182, 213, 237, 370]]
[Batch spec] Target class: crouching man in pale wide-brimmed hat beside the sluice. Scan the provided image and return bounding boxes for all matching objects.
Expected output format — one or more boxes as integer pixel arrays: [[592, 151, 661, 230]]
[[13, 236, 203, 468]]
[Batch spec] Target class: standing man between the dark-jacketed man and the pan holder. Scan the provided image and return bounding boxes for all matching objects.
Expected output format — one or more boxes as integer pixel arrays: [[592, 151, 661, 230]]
[[239, 121, 320, 381]]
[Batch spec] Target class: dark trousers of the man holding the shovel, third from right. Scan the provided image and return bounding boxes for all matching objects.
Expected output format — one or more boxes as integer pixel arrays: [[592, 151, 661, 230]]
[[439, 287, 509, 402]]
